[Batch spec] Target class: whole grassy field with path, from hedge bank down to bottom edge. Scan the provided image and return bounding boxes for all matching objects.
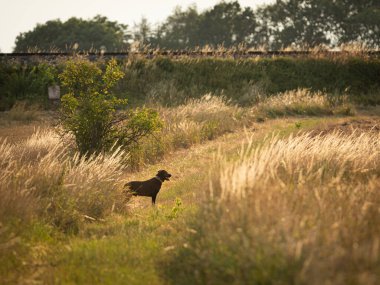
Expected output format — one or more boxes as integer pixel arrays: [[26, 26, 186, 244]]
[[0, 89, 380, 284]]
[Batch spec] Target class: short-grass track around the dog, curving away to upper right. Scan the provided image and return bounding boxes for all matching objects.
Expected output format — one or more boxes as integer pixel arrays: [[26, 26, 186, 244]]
[[126, 119, 306, 210]]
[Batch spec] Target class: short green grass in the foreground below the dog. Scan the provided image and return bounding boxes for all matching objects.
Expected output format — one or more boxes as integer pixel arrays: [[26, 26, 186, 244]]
[[43, 208, 181, 284]]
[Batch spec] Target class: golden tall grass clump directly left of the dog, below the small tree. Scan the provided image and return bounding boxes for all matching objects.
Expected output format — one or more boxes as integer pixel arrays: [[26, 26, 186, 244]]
[[0, 131, 125, 230]]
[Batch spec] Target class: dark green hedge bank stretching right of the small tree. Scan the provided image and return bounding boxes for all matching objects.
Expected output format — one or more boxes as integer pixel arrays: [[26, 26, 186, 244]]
[[120, 58, 380, 104]]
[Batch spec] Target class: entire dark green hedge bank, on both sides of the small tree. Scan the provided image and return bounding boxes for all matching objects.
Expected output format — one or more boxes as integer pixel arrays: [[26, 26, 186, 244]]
[[0, 57, 380, 110]]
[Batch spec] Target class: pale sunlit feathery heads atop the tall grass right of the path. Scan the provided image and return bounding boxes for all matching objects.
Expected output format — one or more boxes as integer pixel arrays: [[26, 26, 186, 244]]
[[220, 131, 380, 197]]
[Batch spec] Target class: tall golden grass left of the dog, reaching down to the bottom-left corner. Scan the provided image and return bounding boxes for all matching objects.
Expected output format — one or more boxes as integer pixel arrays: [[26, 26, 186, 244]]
[[0, 130, 128, 283]]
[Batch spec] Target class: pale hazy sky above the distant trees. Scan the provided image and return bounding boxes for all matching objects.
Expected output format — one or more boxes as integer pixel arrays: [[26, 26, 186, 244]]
[[0, 0, 273, 52]]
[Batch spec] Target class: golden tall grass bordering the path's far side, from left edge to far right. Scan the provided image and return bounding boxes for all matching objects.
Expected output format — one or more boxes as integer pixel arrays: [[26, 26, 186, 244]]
[[0, 90, 356, 223]]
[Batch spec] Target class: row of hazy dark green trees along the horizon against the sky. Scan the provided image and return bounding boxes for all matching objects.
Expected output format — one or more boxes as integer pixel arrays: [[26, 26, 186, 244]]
[[14, 0, 380, 52]]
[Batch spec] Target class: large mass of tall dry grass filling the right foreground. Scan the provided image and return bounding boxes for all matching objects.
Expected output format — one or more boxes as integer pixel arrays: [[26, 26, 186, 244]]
[[168, 129, 380, 285]]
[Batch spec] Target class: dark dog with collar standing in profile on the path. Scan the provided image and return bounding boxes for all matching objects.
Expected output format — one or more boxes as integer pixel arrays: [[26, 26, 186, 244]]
[[125, 170, 172, 205]]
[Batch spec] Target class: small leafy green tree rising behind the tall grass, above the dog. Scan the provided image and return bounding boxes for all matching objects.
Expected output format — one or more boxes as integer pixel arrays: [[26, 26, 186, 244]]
[[59, 59, 162, 154]]
